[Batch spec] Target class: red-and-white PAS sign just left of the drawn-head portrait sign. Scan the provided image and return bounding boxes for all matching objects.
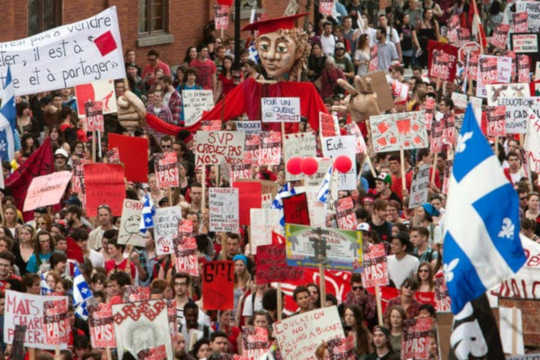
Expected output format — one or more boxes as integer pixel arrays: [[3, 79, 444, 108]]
[[88, 303, 116, 348]]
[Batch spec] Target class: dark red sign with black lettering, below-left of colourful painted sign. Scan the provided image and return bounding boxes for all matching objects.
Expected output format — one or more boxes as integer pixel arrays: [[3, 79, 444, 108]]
[[255, 244, 303, 285]]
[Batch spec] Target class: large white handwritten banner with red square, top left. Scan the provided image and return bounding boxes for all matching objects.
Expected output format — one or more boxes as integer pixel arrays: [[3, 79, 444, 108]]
[[0, 6, 126, 96]]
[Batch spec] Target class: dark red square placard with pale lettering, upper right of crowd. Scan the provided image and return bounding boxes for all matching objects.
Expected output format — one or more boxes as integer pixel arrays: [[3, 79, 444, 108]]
[[428, 40, 458, 82]]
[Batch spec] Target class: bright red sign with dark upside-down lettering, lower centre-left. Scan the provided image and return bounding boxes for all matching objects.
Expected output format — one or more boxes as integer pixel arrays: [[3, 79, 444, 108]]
[[202, 261, 234, 310]]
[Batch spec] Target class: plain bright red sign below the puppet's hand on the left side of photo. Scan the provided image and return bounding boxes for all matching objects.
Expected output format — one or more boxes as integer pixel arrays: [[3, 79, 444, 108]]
[[109, 133, 148, 183]]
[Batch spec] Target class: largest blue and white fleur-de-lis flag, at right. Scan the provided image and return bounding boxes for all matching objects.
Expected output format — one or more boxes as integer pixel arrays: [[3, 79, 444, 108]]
[[443, 104, 526, 314]]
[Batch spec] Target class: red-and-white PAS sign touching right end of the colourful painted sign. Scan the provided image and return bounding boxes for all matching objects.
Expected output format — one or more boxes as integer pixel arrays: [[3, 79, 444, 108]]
[[362, 244, 388, 288]]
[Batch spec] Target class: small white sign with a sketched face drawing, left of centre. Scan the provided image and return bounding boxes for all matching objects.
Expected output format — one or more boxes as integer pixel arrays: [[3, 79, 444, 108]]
[[118, 199, 146, 247]]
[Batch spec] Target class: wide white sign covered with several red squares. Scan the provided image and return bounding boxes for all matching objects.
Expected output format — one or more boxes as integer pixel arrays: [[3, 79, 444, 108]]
[[369, 111, 429, 152]]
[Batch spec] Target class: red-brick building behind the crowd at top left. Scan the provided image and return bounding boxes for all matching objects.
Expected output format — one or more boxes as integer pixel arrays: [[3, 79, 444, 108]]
[[0, 0, 310, 65]]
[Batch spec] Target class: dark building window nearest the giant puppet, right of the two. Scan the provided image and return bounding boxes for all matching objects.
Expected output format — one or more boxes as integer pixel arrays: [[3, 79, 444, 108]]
[[139, 0, 169, 36]]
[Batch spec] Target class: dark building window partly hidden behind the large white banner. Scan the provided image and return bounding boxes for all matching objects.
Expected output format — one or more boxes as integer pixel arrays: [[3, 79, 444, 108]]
[[28, 0, 62, 35]]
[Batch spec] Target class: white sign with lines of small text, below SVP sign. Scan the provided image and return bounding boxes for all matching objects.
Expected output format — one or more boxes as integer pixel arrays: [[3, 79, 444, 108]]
[[208, 188, 239, 233]]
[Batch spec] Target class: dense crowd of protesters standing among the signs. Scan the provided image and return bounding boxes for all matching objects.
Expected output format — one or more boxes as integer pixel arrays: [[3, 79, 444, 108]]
[[0, 0, 540, 359]]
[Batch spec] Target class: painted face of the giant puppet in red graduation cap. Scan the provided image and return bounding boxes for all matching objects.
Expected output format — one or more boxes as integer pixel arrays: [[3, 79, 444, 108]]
[[257, 32, 298, 79]]
